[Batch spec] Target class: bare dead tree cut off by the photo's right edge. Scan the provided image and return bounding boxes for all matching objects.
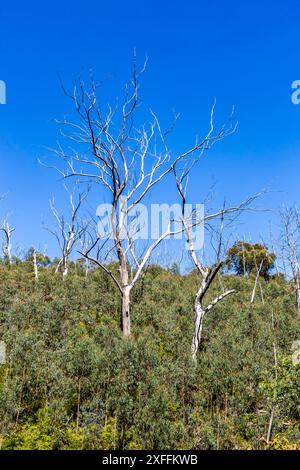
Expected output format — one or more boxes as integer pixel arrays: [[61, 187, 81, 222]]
[[280, 206, 300, 317]]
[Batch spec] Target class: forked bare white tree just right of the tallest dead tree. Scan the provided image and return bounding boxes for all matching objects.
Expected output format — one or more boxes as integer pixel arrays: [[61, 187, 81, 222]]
[[174, 167, 260, 360]]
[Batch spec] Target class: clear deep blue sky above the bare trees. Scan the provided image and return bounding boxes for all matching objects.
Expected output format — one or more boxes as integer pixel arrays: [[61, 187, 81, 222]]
[[0, 0, 300, 258]]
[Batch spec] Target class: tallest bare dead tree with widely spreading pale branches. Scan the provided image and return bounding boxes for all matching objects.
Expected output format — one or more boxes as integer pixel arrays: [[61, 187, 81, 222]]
[[47, 63, 234, 338]]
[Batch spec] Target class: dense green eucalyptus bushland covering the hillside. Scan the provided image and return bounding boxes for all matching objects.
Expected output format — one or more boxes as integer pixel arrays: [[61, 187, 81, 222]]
[[0, 261, 300, 449]]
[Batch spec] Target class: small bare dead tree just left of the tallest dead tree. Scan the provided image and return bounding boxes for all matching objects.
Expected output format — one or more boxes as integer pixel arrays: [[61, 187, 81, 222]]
[[45, 186, 88, 279]]
